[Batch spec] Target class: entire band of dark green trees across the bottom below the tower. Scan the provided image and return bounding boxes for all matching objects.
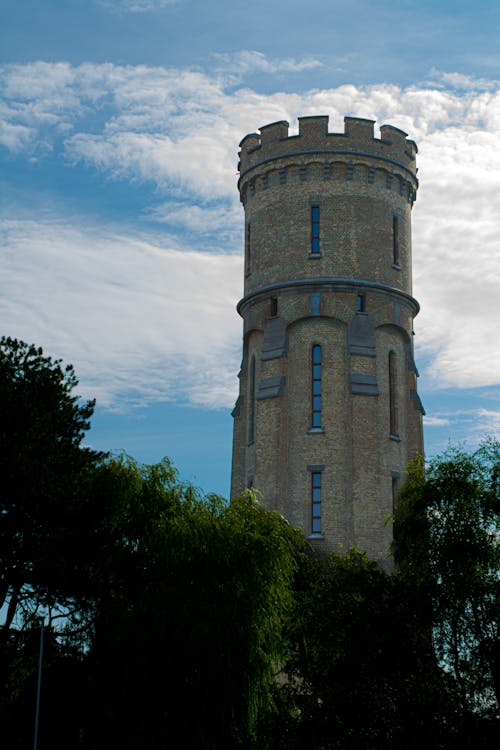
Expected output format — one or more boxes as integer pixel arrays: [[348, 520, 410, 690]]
[[0, 339, 500, 750]]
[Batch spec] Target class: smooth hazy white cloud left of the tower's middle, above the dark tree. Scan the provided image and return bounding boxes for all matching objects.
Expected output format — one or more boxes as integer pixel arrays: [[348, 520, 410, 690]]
[[0, 220, 242, 406]]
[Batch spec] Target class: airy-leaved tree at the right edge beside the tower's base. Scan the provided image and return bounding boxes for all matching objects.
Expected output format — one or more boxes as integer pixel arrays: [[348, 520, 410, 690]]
[[395, 440, 500, 736]]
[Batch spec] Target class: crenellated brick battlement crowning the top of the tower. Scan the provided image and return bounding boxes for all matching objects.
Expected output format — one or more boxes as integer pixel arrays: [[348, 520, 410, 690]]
[[239, 115, 417, 176]]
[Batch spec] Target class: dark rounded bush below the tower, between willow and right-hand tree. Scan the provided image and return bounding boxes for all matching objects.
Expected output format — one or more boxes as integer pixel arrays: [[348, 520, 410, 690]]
[[263, 548, 450, 750]]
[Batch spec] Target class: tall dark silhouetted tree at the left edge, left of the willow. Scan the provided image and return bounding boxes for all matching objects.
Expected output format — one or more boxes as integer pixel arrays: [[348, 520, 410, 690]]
[[0, 337, 99, 630]]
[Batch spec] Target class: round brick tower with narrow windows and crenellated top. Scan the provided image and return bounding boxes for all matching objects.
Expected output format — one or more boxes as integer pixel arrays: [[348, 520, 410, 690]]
[[231, 116, 423, 560]]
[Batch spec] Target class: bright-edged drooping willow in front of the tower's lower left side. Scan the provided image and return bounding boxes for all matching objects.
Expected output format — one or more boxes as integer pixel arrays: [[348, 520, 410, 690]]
[[83, 459, 296, 748]]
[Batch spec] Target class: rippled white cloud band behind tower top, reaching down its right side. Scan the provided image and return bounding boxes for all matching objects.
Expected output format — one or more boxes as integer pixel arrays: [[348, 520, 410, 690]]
[[0, 61, 500, 402]]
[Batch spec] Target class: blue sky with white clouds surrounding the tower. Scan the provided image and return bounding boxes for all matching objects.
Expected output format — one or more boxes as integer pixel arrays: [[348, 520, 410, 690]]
[[0, 0, 500, 496]]
